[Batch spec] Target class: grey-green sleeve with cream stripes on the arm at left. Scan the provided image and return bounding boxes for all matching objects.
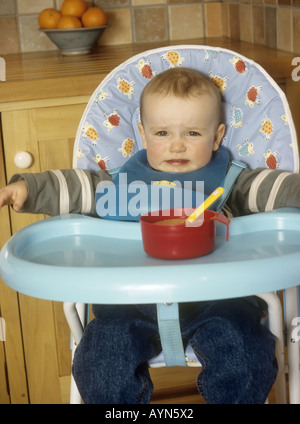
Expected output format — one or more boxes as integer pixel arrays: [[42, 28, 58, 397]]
[[10, 169, 111, 216]]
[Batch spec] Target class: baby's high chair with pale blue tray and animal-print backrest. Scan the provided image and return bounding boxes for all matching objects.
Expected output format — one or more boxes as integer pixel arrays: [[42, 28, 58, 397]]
[[0, 45, 300, 403]]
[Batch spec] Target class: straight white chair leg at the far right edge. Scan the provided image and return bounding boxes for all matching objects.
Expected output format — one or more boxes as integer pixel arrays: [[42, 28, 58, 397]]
[[285, 287, 300, 404]]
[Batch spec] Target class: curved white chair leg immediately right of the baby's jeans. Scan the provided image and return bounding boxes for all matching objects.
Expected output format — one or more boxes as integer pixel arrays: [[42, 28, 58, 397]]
[[258, 293, 287, 404]]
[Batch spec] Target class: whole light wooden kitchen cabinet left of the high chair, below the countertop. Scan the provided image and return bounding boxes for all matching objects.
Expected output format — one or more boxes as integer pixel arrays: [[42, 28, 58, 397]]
[[0, 97, 88, 403]]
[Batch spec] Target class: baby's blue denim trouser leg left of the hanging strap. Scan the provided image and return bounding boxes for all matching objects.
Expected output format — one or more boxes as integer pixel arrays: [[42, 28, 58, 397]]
[[72, 305, 161, 404]]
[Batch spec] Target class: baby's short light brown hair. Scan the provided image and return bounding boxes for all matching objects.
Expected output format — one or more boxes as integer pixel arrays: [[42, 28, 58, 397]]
[[140, 68, 223, 124]]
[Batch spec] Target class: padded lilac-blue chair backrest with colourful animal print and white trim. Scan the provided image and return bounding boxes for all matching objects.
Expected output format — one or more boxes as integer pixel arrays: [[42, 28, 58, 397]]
[[73, 45, 299, 172]]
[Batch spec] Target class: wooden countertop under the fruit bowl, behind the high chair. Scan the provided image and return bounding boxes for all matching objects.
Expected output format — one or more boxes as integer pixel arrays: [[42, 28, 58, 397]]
[[0, 37, 293, 105]]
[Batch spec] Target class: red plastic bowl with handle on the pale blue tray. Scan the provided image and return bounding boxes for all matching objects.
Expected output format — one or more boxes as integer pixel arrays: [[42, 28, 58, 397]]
[[140, 209, 230, 259]]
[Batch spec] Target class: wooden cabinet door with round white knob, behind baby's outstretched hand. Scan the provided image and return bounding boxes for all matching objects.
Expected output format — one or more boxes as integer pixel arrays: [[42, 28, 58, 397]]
[[2, 104, 85, 403]]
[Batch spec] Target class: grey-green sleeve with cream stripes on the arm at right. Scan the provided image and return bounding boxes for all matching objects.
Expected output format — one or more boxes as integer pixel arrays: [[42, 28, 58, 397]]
[[227, 168, 300, 216]]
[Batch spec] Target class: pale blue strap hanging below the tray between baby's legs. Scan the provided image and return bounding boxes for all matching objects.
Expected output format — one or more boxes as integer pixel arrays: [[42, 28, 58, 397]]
[[157, 303, 187, 367]]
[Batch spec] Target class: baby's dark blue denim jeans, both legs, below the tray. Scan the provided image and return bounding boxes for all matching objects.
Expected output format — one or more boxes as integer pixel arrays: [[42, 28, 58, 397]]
[[73, 296, 277, 404]]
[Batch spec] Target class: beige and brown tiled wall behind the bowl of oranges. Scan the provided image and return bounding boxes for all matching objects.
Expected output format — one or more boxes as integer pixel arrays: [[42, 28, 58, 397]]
[[0, 0, 300, 55]]
